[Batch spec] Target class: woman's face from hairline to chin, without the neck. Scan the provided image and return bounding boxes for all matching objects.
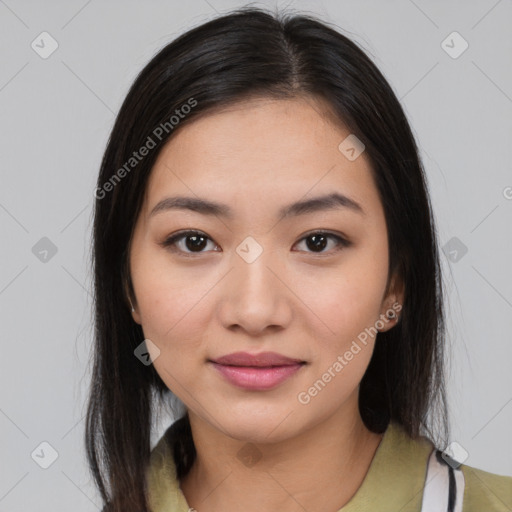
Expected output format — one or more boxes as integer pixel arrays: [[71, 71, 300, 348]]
[[130, 99, 401, 442]]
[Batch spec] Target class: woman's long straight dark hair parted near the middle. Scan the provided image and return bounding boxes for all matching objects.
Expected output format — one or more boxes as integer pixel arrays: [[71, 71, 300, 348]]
[[85, 7, 449, 512]]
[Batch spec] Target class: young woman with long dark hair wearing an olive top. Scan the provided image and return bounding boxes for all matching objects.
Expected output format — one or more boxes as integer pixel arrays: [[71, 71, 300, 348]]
[[86, 5, 512, 512]]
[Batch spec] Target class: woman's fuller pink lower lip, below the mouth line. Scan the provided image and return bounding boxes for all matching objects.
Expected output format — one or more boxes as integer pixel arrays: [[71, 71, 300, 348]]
[[212, 363, 303, 391]]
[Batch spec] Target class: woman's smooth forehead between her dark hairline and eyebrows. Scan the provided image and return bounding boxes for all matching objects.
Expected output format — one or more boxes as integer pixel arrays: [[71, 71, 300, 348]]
[[142, 98, 378, 218]]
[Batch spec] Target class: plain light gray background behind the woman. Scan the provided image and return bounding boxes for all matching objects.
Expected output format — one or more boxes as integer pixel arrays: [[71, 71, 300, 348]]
[[0, 0, 512, 512]]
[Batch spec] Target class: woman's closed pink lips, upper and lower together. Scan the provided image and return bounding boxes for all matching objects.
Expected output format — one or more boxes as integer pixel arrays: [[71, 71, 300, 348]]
[[210, 352, 305, 390]]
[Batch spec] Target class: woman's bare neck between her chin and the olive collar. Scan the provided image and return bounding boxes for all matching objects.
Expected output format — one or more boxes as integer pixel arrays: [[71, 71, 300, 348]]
[[180, 402, 383, 512]]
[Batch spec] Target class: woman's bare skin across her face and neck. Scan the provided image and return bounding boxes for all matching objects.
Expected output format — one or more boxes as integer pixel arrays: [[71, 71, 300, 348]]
[[130, 98, 402, 512]]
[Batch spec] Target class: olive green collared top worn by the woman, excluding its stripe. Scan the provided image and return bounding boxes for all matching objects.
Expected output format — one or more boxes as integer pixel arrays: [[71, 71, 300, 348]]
[[147, 423, 512, 512]]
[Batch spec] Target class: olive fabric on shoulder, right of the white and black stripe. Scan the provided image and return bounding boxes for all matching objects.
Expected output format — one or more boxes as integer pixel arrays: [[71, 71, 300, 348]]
[[459, 464, 512, 512]]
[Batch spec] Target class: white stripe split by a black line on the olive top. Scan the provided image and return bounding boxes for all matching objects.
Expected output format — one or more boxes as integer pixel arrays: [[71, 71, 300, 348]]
[[421, 449, 465, 512]]
